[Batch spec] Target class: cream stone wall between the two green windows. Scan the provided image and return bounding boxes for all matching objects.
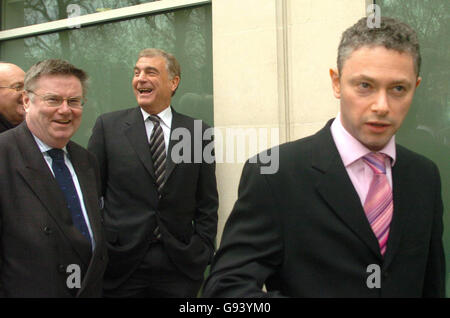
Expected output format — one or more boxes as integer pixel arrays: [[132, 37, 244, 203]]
[[212, 0, 366, 242]]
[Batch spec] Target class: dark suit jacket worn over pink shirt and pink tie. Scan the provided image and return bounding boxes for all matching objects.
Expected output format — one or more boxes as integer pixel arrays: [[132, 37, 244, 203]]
[[204, 121, 445, 297]]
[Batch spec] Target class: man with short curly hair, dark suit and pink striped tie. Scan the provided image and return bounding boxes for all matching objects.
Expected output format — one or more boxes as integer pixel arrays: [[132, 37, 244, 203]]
[[204, 18, 445, 297]]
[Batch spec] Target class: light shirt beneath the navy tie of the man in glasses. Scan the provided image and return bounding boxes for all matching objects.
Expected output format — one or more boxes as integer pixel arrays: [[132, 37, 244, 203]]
[[33, 135, 95, 250]]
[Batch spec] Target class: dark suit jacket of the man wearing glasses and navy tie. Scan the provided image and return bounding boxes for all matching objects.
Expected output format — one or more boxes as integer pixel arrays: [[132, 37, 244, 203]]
[[0, 122, 107, 297]]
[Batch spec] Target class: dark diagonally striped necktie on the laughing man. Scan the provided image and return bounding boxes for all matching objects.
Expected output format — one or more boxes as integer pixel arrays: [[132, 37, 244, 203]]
[[149, 115, 166, 195]]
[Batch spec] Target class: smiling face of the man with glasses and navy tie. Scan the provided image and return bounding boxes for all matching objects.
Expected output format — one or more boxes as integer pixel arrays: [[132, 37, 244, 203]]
[[24, 75, 83, 148]]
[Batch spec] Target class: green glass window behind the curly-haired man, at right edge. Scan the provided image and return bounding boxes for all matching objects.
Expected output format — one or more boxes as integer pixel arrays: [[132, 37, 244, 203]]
[[377, 0, 450, 296]]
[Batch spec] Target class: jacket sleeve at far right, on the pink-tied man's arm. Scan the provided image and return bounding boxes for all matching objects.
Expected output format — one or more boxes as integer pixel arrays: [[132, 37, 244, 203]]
[[423, 161, 446, 297]]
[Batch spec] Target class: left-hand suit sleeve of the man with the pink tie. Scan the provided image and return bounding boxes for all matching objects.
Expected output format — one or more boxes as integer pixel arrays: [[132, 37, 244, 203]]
[[203, 163, 283, 297]]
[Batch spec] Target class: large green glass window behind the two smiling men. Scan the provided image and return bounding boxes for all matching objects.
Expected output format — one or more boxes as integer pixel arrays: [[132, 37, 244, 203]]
[[0, 1, 213, 146]]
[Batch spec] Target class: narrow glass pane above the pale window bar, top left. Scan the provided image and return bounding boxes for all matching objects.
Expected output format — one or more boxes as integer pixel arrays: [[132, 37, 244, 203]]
[[2, 0, 161, 30]]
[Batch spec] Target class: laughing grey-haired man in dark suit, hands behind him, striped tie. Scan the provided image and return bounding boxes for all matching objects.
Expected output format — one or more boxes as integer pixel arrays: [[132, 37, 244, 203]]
[[88, 49, 218, 297]]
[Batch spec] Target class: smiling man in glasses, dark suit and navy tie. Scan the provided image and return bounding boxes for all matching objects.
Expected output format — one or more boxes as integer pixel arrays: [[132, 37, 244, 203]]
[[0, 60, 107, 297]]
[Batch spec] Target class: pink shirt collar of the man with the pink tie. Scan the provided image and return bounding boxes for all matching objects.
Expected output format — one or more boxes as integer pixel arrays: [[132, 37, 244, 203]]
[[331, 112, 396, 167]]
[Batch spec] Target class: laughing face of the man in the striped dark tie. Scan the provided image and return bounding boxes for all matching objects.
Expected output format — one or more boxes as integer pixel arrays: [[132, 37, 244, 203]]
[[132, 56, 180, 114]]
